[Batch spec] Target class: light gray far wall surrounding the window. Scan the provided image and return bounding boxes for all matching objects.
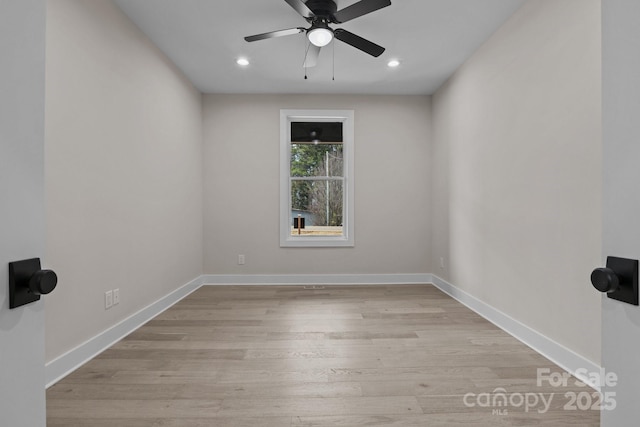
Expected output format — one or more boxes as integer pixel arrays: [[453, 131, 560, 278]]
[[203, 95, 431, 274]]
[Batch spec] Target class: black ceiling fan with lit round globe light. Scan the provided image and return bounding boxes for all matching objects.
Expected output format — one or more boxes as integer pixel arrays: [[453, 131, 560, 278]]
[[244, 0, 391, 68]]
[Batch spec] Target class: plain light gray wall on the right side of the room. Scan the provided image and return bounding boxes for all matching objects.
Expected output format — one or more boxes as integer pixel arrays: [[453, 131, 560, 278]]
[[432, 0, 602, 364]]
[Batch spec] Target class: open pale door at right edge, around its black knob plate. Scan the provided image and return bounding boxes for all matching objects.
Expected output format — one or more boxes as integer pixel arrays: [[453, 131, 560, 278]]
[[601, 0, 640, 427]]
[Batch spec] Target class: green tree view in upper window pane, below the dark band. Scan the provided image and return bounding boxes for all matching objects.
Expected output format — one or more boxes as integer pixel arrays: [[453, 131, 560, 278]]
[[290, 143, 344, 177]]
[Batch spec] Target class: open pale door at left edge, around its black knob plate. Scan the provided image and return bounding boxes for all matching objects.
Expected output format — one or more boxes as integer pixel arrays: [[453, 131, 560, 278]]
[[0, 0, 46, 427]]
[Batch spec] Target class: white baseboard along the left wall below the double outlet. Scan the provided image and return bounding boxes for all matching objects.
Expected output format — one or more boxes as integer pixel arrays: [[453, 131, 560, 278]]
[[45, 276, 203, 388]]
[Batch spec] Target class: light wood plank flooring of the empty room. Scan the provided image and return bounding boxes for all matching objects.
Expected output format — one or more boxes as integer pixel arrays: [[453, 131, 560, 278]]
[[47, 285, 600, 427]]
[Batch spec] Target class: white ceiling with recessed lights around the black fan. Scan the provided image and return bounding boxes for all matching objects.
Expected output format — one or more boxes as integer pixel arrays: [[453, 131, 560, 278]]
[[115, 0, 525, 94]]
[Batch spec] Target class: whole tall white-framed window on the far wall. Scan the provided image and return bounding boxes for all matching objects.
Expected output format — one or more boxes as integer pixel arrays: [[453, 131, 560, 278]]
[[280, 110, 354, 246]]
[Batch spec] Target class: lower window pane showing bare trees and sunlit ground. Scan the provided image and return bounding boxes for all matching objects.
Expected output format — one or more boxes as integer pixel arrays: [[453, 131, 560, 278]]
[[290, 179, 344, 236]]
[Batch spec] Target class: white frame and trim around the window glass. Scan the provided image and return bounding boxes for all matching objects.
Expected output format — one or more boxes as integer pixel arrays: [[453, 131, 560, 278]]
[[280, 110, 355, 247]]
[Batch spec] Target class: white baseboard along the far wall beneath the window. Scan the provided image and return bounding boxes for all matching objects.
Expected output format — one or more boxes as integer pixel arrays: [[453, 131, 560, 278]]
[[202, 273, 432, 285]]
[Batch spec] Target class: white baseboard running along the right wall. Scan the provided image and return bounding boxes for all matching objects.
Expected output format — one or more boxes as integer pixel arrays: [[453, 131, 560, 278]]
[[431, 274, 601, 391]]
